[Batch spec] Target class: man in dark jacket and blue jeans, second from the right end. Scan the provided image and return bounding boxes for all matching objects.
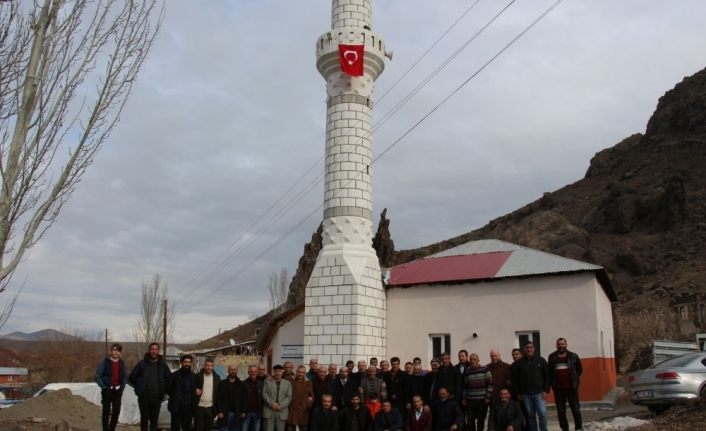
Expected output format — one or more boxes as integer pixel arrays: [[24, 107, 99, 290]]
[[512, 341, 549, 431]]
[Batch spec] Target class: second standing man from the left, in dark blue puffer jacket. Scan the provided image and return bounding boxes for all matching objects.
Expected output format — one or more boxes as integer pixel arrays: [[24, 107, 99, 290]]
[[128, 343, 171, 431]]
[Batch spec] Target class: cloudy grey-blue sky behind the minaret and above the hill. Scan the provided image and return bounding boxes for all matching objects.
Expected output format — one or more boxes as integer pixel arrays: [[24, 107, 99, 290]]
[[0, 0, 706, 342]]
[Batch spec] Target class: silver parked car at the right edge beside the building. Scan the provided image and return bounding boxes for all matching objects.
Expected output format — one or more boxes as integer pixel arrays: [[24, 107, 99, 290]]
[[628, 352, 706, 413]]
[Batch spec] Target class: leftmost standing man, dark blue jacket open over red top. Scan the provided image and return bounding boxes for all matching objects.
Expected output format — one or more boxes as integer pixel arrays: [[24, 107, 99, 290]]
[[96, 343, 127, 431]]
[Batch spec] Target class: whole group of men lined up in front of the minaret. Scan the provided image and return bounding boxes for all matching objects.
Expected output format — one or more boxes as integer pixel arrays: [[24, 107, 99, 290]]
[[96, 338, 582, 431]]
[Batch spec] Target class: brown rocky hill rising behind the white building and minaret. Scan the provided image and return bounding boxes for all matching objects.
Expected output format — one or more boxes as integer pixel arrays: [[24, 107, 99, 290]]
[[209, 69, 706, 371]]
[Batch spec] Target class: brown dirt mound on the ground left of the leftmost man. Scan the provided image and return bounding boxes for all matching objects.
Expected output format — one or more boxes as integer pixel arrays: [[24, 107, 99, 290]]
[[0, 389, 101, 431]]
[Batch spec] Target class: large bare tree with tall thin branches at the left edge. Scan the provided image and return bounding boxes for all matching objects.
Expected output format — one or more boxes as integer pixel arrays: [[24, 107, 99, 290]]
[[0, 0, 164, 330]]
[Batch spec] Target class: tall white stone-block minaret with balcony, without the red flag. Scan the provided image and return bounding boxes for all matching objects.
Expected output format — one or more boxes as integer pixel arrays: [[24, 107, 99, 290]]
[[304, 0, 389, 365]]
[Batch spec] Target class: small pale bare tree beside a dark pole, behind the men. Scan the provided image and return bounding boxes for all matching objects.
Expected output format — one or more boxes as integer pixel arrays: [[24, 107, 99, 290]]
[[134, 274, 175, 352]]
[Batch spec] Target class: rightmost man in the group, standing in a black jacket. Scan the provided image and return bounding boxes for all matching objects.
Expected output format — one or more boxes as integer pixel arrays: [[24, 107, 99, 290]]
[[548, 338, 583, 431]]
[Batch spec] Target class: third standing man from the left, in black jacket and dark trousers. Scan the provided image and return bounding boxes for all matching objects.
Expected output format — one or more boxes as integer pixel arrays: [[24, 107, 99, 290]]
[[167, 355, 198, 431]]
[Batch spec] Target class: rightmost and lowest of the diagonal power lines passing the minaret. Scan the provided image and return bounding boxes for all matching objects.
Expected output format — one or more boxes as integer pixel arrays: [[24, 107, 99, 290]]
[[177, 0, 563, 314]]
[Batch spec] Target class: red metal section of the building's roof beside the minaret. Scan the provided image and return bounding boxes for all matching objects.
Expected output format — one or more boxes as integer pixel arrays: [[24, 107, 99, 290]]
[[387, 251, 512, 286]]
